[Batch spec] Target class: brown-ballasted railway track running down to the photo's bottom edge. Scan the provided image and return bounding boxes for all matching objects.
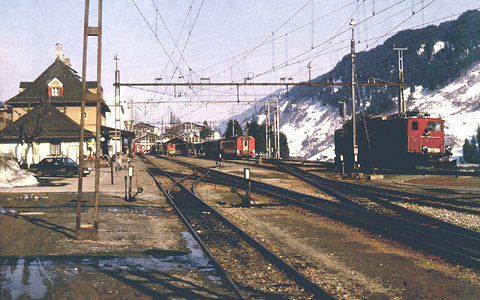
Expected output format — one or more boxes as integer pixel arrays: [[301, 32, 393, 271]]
[[141, 156, 333, 299]]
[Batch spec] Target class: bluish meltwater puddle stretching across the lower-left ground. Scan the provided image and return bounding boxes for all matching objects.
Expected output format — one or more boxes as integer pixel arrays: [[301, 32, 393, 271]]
[[0, 232, 222, 300]]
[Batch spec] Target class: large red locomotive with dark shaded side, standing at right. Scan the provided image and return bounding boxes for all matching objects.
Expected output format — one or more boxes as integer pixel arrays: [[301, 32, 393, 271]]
[[335, 112, 456, 172]]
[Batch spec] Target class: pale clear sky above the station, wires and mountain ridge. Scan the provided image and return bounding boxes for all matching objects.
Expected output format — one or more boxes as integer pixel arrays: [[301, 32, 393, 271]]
[[0, 0, 480, 122]]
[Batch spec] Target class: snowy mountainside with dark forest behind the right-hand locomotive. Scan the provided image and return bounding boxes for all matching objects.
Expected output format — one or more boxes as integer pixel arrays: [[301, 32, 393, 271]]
[[238, 10, 480, 160]]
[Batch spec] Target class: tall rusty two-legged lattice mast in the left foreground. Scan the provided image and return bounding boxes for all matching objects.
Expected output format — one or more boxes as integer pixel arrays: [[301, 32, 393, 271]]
[[75, 0, 102, 241]]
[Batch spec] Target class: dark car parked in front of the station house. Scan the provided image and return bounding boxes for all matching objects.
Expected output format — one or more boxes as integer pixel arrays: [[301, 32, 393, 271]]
[[30, 156, 90, 177]]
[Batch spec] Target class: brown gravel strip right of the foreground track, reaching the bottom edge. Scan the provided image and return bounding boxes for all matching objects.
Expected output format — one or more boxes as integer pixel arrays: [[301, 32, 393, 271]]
[[194, 180, 480, 299]]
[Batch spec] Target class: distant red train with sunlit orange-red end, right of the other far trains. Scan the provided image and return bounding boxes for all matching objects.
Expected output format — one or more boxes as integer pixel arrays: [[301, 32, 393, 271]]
[[202, 135, 255, 158]]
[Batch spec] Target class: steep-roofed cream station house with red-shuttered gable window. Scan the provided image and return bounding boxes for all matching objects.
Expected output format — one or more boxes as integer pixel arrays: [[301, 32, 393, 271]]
[[0, 44, 134, 165]]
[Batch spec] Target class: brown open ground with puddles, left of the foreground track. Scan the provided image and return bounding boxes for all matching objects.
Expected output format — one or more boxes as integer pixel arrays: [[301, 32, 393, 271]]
[[0, 158, 238, 299]]
